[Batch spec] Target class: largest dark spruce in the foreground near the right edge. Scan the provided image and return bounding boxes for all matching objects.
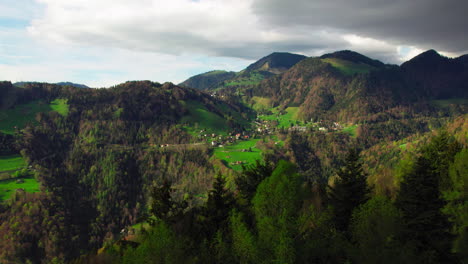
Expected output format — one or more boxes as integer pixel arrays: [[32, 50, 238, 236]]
[[396, 133, 454, 263]]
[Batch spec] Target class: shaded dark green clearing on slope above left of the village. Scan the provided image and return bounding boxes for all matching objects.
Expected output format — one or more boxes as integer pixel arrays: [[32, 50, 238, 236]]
[[181, 101, 227, 134]]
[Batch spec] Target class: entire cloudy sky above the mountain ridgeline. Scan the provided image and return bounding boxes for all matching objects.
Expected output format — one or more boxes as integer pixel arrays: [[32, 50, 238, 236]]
[[0, 0, 468, 87]]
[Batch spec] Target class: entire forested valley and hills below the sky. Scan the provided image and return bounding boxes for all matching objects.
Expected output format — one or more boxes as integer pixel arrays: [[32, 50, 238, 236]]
[[0, 51, 468, 263]]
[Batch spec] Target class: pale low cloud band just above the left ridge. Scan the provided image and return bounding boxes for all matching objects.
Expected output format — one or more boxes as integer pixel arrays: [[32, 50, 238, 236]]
[[0, 38, 251, 87]]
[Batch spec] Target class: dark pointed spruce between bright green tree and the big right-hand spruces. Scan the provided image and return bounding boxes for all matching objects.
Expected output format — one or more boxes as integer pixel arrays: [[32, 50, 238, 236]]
[[329, 148, 369, 231]]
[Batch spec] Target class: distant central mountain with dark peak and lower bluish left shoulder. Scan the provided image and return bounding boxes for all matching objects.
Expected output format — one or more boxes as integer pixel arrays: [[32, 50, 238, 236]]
[[180, 52, 307, 91]]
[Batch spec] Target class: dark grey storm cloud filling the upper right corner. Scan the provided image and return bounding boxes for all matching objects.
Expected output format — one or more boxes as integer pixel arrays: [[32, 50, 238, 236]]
[[253, 0, 468, 52]]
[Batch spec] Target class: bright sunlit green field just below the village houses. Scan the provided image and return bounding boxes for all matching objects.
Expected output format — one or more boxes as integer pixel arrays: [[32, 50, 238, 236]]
[[214, 139, 262, 171]]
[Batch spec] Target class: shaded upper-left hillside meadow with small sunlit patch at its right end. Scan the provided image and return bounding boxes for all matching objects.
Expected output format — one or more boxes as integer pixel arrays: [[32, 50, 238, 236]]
[[0, 99, 68, 134]]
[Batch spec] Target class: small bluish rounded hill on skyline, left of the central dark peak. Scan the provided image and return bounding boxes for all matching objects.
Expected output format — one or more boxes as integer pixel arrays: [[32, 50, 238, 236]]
[[179, 71, 236, 90]]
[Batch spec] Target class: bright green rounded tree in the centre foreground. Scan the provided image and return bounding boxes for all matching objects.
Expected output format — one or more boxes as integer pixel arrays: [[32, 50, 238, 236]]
[[252, 160, 303, 263]]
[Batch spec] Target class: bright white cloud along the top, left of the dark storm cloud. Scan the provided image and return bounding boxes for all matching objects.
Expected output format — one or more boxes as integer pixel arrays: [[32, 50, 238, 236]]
[[28, 0, 352, 59]]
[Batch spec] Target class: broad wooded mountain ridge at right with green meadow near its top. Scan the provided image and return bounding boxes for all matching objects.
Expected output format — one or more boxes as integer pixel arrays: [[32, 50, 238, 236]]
[[252, 51, 468, 121]]
